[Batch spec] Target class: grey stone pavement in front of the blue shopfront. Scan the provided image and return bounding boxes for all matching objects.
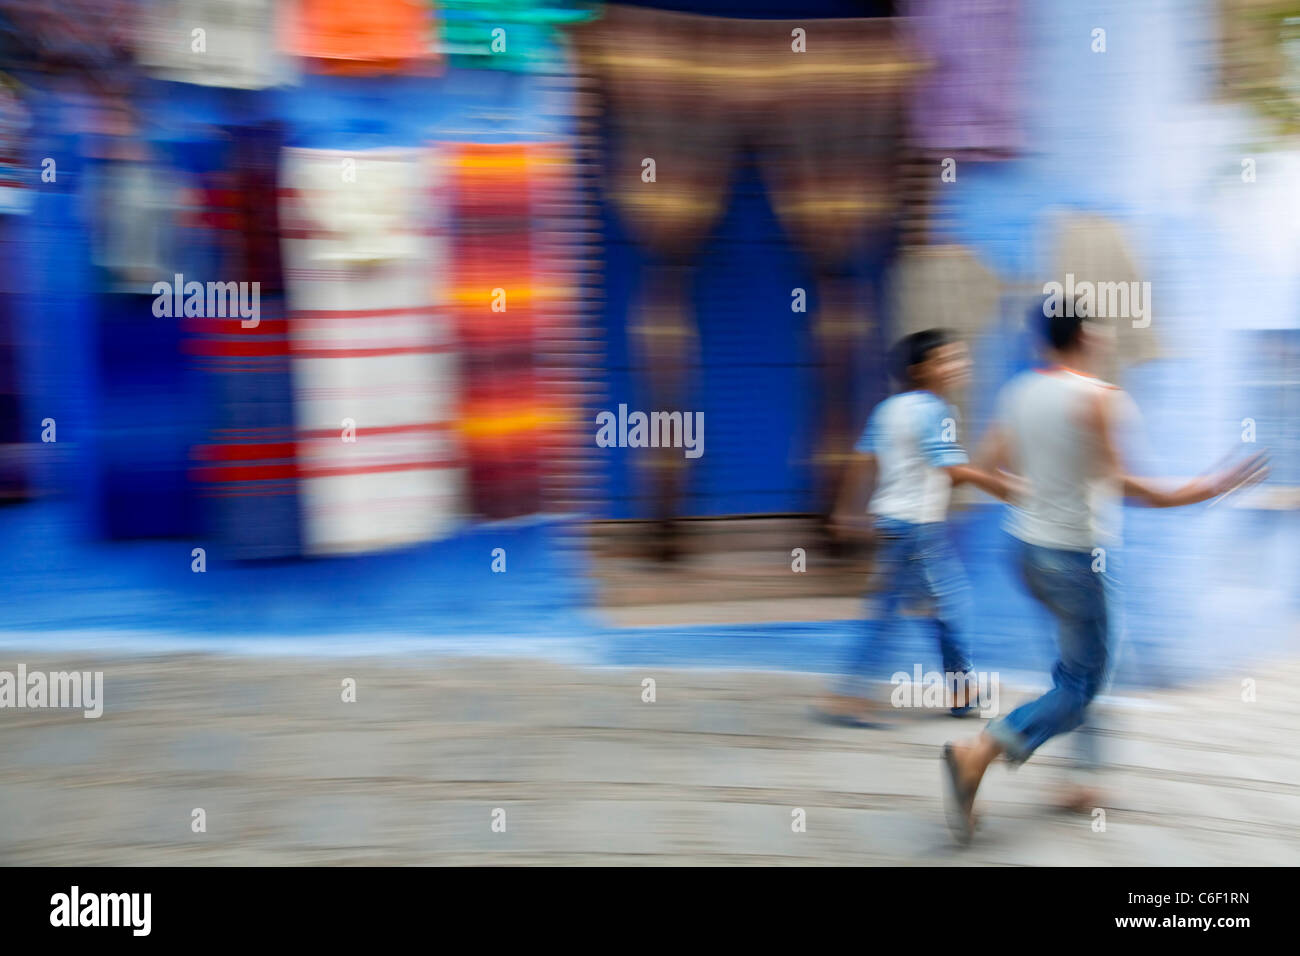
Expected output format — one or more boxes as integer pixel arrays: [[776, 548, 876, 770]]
[[0, 650, 1300, 866]]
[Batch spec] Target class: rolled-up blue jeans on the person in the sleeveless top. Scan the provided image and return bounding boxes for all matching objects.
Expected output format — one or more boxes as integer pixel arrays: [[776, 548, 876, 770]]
[[988, 541, 1109, 763]]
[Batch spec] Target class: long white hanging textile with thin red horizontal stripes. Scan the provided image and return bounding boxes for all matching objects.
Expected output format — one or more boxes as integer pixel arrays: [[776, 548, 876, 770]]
[[281, 148, 464, 554]]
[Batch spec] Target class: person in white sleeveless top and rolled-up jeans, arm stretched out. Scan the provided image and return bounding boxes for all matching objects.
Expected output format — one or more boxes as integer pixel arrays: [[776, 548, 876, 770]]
[[943, 302, 1266, 843]]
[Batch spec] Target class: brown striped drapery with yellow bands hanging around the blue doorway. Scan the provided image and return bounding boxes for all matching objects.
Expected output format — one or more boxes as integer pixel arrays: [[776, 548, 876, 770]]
[[576, 5, 920, 558]]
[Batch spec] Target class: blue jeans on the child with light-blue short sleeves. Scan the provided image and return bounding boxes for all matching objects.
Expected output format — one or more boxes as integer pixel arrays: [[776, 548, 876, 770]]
[[837, 518, 971, 696]]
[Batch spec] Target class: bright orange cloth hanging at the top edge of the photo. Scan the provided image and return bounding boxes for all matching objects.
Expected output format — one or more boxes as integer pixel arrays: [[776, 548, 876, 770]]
[[287, 0, 438, 74]]
